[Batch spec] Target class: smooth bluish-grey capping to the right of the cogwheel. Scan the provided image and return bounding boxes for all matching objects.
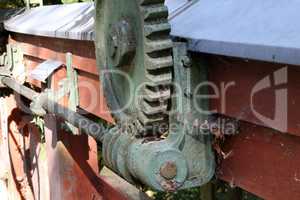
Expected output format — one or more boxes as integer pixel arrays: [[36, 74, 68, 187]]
[[169, 0, 300, 65]]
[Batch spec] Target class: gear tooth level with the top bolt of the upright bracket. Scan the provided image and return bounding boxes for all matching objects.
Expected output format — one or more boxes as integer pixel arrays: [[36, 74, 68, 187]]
[[145, 55, 173, 70]]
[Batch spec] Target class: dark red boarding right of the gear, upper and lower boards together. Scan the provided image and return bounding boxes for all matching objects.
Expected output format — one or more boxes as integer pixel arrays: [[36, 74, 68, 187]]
[[206, 55, 300, 200]]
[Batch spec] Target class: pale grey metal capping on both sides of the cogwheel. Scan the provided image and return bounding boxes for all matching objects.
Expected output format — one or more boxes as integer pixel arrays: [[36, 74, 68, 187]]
[[5, 0, 300, 65]]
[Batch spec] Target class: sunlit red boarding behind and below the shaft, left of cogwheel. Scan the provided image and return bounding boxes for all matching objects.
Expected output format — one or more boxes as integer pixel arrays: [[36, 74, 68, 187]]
[[0, 32, 120, 200]]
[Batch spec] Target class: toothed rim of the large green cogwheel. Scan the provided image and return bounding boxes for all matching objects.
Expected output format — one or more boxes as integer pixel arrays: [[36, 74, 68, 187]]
[[96, 0, 173, 137]]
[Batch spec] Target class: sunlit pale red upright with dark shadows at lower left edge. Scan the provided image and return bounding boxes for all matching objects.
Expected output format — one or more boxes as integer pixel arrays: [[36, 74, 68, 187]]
[[1, 95, 49, 200]]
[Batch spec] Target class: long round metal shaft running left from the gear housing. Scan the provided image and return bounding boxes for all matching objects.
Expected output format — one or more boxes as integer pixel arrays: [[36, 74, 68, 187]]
[[1, 77, 106, 142]]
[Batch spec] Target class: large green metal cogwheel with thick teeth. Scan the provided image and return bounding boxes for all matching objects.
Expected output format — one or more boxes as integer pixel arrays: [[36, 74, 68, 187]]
[[95, 0, 173, 133]]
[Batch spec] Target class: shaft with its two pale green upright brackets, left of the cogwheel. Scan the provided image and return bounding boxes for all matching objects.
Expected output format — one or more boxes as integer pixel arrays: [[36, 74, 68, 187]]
[[0, 44, 107, 141]]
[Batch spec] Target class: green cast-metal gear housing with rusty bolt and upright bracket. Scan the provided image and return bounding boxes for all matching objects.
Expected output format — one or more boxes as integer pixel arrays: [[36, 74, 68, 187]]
[[103, 43, 215, 191]]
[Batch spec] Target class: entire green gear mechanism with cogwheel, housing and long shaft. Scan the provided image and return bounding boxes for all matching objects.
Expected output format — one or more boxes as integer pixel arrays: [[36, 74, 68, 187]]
[[0, 0, 215, 191]]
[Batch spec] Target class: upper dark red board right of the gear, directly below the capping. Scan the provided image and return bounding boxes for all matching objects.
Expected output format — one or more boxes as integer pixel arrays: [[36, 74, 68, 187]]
[[208, 56, 300, 136]]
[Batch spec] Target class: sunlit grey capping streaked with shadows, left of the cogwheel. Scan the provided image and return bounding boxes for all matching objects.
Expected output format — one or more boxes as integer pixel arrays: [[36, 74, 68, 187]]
[[4, 3, 94, 40]]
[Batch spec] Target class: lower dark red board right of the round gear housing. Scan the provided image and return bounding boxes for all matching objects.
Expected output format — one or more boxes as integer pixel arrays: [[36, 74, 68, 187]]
[[218, 122, 300, 200]]
